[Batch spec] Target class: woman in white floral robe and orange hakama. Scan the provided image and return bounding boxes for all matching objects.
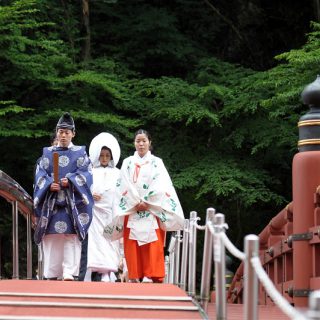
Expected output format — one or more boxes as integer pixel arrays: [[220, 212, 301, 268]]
[[107, 129, 184, 282]]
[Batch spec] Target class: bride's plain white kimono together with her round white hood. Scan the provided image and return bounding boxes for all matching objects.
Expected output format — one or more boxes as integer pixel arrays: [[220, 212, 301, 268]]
[[85, 133, 121, 281]]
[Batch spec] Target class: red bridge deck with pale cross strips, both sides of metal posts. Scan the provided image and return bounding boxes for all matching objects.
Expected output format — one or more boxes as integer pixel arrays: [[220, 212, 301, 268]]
[[0, 280, 302, 320]]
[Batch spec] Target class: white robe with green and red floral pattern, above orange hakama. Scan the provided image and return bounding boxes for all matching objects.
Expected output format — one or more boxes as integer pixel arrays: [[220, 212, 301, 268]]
[[104, 151, 184, 245]]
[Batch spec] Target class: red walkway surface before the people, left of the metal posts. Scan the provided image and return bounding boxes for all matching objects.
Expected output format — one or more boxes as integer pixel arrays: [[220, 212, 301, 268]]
[[0, 280, 202, 319]]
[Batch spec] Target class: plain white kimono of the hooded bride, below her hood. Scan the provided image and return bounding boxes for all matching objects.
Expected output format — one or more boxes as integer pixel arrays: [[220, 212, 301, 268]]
[[87, 166, 120, 273]]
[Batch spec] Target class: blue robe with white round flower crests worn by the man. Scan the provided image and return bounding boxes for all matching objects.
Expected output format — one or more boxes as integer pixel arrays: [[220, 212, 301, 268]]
[[33, 145, 93, 244]]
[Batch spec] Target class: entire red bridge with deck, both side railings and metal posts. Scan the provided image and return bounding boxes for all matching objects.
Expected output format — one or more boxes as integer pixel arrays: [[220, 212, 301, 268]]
[[0, 77, 320, 320]]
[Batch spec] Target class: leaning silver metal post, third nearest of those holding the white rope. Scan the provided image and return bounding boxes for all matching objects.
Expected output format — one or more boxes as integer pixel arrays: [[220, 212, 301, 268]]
[[200, 208, 215, 311]]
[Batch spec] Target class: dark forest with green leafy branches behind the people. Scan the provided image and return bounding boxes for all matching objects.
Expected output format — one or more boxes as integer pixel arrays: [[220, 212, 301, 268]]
[[0, 0, 320, 277]]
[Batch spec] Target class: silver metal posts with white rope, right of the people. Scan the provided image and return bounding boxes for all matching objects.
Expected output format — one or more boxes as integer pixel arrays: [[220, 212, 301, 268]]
[[165, 208, 320, 320]]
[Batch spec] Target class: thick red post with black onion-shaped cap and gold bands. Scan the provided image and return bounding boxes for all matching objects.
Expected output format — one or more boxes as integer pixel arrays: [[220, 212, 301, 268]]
[[290, 76, 320, 306]]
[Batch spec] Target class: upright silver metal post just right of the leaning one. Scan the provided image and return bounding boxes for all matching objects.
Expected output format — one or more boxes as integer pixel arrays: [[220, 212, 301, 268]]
[[213, 213, 227, 320]]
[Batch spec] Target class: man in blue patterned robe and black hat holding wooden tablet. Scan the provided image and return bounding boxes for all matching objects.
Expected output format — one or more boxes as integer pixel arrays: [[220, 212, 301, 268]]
[[34, 113, 93, 280]]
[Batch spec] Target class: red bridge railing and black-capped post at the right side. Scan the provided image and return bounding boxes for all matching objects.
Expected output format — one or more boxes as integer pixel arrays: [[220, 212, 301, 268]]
[[228, 76, 320, 307]]
